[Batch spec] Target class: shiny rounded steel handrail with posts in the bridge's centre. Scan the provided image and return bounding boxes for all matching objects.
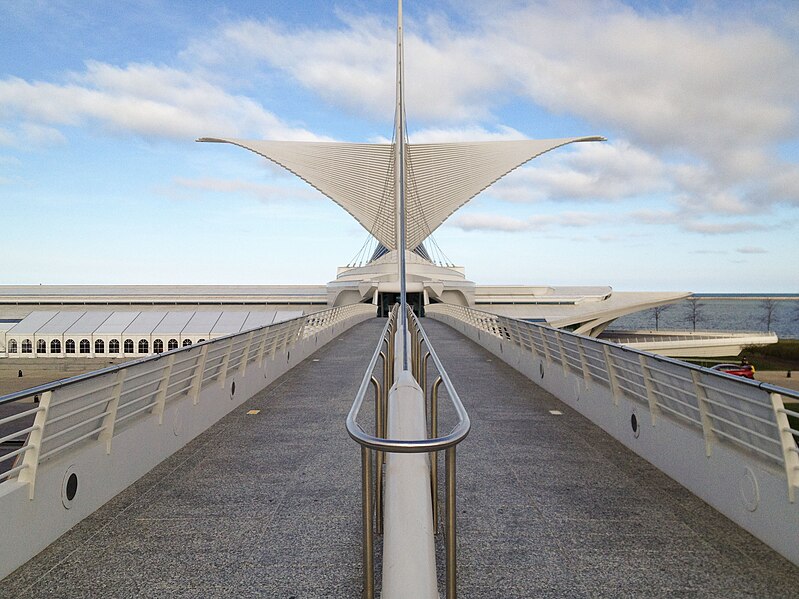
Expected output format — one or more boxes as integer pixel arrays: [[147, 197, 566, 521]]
[[346, 306, 471, 599]]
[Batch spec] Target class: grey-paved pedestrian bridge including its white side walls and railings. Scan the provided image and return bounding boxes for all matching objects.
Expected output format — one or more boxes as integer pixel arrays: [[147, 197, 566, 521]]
[[0, 309, 799, 598]]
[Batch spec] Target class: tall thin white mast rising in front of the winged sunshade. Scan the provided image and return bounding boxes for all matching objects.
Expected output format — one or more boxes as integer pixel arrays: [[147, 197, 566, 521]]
[[394, 0, 409, 370]]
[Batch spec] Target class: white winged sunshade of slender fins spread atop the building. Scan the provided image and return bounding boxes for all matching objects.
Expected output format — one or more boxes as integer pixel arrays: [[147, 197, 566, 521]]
[[198, 136, 604, 250]]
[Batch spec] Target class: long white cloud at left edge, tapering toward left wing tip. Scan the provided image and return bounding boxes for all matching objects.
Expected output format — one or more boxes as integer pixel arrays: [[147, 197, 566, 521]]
[[0, 62, 328, 140]]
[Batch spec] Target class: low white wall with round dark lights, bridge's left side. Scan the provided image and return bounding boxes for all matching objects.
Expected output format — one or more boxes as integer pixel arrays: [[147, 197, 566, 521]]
[[0, 304, 375, 578]]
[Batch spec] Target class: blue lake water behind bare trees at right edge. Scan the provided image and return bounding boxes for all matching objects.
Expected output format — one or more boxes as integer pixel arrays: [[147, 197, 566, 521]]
[[610, 294, 799, 339]]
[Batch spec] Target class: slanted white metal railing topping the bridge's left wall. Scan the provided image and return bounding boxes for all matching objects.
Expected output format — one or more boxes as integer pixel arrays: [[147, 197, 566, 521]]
[[0, 304, 375, 498]]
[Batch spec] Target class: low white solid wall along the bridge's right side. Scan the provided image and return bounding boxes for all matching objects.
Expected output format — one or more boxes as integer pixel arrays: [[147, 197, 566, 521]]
[[427, 305, 799, 565]]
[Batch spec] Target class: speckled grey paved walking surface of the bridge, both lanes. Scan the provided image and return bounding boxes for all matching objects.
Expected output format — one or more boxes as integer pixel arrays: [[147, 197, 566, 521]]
[[0, 319, 799, 598]]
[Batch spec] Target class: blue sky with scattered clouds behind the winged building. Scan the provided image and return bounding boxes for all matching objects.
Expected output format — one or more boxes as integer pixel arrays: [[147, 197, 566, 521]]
[[0, 0, 799, 293]]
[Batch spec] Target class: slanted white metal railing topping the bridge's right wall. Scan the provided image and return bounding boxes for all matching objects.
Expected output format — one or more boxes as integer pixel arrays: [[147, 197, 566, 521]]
[[426, 304, 799, 502]]
